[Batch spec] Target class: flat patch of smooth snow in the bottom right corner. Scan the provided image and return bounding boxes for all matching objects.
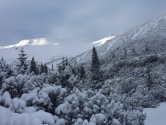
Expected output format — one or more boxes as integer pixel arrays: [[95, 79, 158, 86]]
[[144, 102, 166, 125]]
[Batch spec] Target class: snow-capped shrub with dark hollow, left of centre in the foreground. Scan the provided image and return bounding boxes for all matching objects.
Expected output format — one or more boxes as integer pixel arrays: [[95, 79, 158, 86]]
[[21, 84, 67, 114]]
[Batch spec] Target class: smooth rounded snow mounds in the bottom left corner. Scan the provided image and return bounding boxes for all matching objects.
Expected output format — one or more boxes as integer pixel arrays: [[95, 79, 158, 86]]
[[0, 106, 56, 125]]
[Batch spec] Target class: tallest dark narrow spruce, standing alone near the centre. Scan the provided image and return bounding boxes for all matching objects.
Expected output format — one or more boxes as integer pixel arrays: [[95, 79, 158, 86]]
[[91, 47, 102, 88]]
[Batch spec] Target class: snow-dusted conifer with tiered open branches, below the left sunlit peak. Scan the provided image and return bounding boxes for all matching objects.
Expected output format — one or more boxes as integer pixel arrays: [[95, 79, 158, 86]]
[[17, 48, 27, 73]]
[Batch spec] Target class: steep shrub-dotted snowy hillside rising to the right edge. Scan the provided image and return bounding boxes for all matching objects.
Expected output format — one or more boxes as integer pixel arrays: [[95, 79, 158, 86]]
[[70, 9, 166, 108]]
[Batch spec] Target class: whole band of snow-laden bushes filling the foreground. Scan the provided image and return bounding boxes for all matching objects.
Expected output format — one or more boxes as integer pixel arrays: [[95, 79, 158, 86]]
[[0, 76, 145, 125]]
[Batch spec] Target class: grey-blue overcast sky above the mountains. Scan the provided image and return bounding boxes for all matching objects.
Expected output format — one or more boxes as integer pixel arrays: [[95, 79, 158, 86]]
[[0, 0, 166, 46]]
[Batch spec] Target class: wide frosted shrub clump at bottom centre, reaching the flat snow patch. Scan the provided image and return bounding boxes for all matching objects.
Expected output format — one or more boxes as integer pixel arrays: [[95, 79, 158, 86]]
[[55, 88, 145, 125]]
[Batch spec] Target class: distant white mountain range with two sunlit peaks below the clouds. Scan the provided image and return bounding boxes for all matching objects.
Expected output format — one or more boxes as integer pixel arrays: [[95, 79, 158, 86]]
[[0, 35, 115, 63]]
